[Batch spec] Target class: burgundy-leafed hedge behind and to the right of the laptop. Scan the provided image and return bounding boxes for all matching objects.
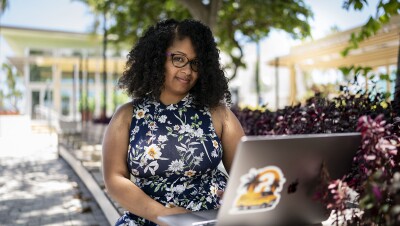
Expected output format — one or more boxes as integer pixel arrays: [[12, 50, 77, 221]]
[[232, 87, 400, 225]]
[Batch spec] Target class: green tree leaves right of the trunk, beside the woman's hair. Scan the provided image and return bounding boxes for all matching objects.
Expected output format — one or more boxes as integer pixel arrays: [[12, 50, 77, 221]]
[[215, 0, 313, 77]]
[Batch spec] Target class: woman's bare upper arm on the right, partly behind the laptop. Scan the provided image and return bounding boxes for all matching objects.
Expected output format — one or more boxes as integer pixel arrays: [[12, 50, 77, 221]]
[[212, 106, 245, 173]]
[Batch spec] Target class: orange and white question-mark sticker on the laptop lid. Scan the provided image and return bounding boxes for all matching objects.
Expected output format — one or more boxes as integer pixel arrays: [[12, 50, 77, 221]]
[[230, 166, 286, 214]]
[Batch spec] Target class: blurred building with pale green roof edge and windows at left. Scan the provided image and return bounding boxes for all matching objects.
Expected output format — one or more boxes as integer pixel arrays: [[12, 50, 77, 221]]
[[1, 26, 126, 121]]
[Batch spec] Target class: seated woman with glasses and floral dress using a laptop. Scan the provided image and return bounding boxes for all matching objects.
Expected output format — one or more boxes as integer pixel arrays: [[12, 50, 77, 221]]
[[103, 19, 244, 225]]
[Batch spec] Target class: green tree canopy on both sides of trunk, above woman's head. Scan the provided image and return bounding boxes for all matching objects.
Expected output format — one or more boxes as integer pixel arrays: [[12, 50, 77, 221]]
[[80, 0, 312, 80]]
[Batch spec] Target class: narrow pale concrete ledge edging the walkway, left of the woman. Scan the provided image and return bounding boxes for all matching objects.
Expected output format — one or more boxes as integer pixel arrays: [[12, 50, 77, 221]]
[[59, 145, 120, 225]]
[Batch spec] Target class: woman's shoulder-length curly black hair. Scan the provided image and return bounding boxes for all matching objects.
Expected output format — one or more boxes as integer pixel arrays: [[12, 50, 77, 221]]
[[118, 19, 231, 108]]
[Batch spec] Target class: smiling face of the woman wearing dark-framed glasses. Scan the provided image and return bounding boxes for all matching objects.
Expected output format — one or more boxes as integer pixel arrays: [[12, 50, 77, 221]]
[[160, 38, 198, 104]]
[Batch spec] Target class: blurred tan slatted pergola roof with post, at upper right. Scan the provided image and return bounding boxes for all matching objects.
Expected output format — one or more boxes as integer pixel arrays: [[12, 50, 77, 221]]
[[267, 16, 400, 104]]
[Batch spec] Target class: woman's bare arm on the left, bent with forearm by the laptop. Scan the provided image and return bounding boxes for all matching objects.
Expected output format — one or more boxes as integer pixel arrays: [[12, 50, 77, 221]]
[[102, 103, 187, 225]]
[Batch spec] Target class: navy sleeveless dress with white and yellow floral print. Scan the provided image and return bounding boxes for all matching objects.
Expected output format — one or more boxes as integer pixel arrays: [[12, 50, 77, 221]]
[[116, 95, 227, 226]]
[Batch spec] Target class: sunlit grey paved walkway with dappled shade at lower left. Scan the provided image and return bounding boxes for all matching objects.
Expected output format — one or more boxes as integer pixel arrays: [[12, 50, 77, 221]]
[[0, 134, 109, 226]]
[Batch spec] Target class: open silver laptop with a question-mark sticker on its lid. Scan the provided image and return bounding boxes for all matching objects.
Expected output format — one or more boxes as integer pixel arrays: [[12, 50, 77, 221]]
[[159, 133, 361, 226]]
